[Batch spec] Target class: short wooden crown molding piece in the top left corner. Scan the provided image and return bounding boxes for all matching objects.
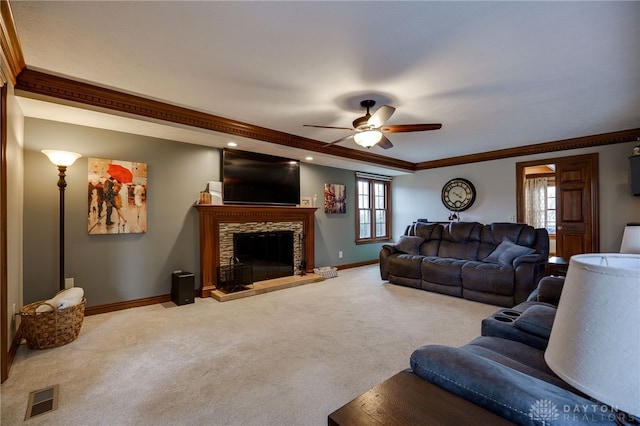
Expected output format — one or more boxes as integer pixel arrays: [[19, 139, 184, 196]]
[[0, 0, 26, 84]]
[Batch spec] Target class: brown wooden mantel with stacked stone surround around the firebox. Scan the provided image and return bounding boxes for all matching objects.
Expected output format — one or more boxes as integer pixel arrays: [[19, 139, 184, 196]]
[[195, 204, 316, 297]]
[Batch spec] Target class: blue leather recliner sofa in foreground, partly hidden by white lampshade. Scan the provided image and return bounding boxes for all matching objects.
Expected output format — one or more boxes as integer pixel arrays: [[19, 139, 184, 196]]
[[410, 277, 624, 426]]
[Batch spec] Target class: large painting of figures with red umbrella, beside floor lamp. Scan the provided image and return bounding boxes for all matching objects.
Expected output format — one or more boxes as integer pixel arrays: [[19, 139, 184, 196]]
[[87, 158, 147, 235]]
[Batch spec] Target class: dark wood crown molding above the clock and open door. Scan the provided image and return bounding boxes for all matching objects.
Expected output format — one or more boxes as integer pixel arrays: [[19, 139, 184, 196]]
[[415, 129, 640, 170]]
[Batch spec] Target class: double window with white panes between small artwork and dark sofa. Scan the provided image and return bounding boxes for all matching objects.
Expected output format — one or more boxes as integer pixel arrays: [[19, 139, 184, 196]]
[[356, 173, 391, 244]]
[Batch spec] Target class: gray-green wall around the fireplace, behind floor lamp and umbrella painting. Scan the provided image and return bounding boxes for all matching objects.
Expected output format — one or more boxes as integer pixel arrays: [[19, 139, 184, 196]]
[[24, 118, 380, 306]]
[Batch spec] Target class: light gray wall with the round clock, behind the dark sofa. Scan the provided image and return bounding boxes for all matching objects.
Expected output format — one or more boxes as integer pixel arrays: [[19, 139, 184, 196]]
[[392, 142, 640, 252]]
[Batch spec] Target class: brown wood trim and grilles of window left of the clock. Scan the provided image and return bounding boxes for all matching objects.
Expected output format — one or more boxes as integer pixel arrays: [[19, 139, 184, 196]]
[[354, 172, 392, 245]]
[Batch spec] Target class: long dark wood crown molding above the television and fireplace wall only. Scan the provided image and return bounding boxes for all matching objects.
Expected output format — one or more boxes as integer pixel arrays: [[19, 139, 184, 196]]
[[15, 68, 414, 171]]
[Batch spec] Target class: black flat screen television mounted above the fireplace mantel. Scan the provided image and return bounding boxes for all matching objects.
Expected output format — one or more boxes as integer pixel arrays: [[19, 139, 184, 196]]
[[221, 148, 300, 206]]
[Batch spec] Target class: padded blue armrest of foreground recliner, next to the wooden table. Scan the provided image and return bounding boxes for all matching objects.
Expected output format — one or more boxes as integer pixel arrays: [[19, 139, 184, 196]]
[[411, 345, 615, 426]]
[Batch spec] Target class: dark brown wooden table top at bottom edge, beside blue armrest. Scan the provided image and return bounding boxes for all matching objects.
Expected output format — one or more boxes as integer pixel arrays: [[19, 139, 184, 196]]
[[328, 371, 514, 426]]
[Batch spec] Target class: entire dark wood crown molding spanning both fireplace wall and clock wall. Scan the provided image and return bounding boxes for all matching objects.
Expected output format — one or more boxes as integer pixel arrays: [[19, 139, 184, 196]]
[[15, 68, 640, 172]]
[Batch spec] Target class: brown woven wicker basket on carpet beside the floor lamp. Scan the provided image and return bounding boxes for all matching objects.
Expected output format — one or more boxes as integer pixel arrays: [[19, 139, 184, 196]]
[[20, 297, 87, 349]]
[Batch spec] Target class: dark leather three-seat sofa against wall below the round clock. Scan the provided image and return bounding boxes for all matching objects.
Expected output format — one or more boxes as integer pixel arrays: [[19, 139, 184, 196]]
[[380, 222, 549, 307]]
